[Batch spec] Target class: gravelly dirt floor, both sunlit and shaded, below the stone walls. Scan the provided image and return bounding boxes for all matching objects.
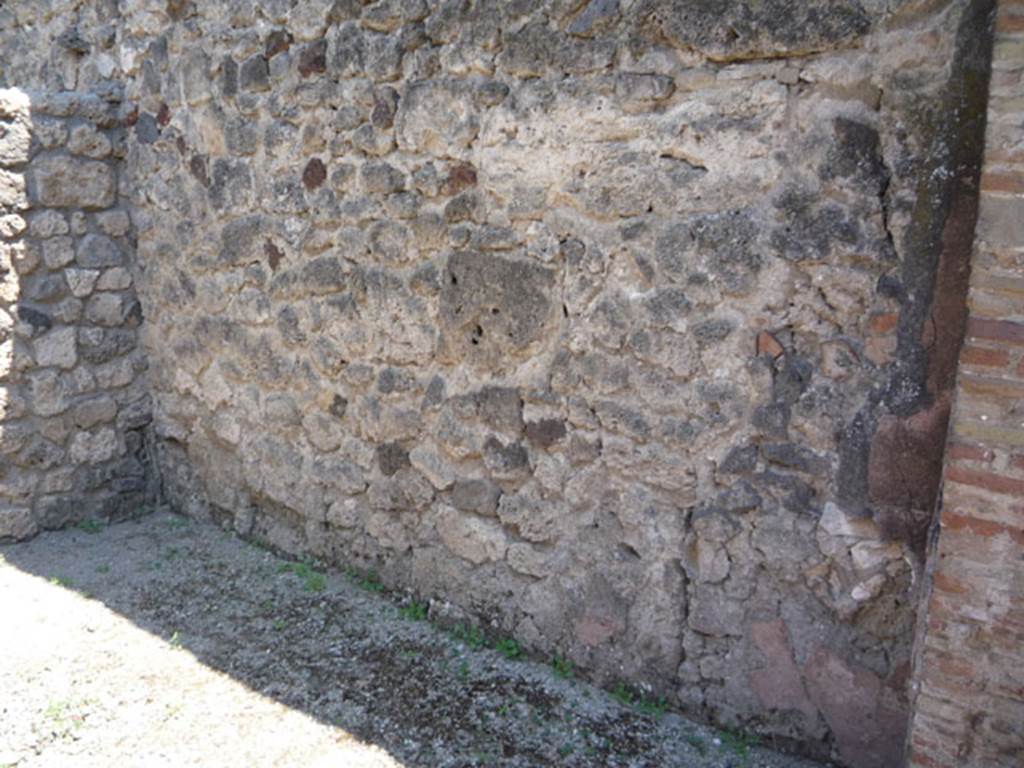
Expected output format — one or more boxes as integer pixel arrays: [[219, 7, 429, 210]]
[[0, 513, 816, 768]]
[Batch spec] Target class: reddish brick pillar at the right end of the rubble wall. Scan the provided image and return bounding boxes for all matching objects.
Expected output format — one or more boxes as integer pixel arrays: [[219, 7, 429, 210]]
[[907, 0, 1024, 768]]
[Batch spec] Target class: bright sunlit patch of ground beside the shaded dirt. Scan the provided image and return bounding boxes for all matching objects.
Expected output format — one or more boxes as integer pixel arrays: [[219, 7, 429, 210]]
[[0, 552, 401, 768]]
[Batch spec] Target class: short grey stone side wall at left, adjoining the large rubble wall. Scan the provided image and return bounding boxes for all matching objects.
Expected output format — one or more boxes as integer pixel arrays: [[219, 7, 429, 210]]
[[0, 83, 153, 539]]
